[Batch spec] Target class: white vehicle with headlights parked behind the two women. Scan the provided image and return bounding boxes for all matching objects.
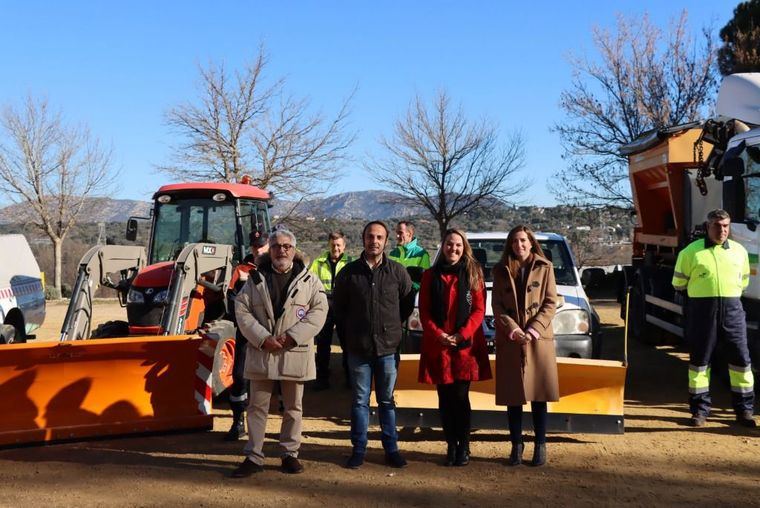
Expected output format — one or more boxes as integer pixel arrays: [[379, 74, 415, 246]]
[[404, 232, 601, 358]]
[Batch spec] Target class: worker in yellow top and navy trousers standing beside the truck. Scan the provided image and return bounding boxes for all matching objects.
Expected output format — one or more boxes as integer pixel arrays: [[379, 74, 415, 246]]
[[673, 209, 756, 427]]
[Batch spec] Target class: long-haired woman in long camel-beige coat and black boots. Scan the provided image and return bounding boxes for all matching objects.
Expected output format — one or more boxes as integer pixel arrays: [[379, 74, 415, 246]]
[[492, 226, 559, 466]]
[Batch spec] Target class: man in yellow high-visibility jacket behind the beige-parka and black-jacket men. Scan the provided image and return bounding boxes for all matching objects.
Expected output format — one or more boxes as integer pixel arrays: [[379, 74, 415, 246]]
[[309, 231, 353, 391]]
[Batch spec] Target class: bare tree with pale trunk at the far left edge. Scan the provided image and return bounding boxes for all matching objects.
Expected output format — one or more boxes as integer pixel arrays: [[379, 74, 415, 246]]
[[0, 97, 115, 291]]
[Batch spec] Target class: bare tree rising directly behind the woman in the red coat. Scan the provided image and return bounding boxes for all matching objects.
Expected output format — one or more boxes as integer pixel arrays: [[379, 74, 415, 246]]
[[367, 91, 527, 238]]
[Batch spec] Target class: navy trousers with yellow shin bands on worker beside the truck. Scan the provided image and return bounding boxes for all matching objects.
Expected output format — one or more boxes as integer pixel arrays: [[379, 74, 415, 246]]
[[686, 298, 755, 416]]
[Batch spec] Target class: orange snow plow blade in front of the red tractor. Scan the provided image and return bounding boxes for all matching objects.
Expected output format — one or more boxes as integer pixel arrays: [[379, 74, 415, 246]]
[[0, 336, 215, 446]]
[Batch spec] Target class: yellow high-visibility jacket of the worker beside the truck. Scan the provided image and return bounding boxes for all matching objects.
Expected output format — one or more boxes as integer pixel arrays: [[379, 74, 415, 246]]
[[673, 238, 749, 298]]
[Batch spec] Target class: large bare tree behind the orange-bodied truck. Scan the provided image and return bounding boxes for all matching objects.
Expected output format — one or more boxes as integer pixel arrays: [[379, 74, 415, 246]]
[[550, 11, 716, 207]]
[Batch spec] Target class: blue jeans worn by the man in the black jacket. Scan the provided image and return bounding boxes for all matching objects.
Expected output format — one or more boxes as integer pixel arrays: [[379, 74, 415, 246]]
[[348, 354, 398, 455]]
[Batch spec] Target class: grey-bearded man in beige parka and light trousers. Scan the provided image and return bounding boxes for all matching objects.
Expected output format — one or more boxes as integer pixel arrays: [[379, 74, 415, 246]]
[[232, 229, 327, 478]]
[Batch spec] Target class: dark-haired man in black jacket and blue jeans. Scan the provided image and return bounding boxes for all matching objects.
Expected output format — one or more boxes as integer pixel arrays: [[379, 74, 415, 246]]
[[333, 221, 414, 469]]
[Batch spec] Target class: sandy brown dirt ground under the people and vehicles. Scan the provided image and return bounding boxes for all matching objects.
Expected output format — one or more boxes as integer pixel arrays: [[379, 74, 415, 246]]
[[0, 301, 760, 507]]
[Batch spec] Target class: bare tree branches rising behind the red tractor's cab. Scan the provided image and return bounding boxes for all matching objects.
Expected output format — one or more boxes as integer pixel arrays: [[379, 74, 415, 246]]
[[160, 49, 354, 199]]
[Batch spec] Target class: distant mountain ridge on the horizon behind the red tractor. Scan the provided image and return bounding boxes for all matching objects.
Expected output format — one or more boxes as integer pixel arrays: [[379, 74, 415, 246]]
[[0, 190, 425, 224]]
